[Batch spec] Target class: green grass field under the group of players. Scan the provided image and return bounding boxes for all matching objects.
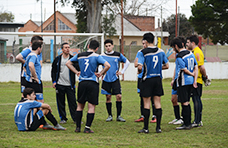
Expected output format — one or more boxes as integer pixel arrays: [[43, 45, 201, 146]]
[[0, 79, 228, 148]]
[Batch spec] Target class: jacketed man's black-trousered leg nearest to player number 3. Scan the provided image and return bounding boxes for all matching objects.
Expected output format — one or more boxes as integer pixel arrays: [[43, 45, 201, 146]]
[[66, 86, 77, 122]]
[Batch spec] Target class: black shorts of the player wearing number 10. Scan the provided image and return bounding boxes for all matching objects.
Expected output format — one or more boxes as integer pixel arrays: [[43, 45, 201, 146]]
[[177, 85, 193, 103]]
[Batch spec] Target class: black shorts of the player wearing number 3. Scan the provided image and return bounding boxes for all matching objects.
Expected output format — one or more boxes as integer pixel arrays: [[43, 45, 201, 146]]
[[77, 81, 99, 105]]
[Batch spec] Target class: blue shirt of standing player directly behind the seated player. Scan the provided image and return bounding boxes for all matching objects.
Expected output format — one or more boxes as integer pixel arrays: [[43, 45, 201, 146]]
[[24, 52, 41, 84]]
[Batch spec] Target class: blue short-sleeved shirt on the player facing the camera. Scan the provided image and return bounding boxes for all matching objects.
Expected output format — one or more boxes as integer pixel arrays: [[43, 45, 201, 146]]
[[101, 51, 127, 82]]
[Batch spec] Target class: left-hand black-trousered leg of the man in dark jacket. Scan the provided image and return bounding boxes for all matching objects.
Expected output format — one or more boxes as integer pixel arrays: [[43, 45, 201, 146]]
[[56, 84, 67, 124]]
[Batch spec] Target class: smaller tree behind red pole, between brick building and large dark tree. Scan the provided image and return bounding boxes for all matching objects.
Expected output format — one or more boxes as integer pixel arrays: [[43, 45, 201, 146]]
[[162, 13, 192, 41]]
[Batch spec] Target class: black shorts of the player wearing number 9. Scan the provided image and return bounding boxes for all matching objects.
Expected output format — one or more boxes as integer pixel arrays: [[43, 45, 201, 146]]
[[140, 77, 164, 97]]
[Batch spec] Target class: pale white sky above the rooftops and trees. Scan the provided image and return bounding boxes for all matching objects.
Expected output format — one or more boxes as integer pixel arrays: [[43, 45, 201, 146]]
[[0, 0, 195, 26]]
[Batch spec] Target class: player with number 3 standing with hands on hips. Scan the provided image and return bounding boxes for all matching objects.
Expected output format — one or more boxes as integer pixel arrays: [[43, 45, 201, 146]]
[[66, 40, 110, 133]]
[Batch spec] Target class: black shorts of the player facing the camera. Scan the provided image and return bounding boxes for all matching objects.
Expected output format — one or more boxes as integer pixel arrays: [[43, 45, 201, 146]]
[[101, 79, 121, 95]]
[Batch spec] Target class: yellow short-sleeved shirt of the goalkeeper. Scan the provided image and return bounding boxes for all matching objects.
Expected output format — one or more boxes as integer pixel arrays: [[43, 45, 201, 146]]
[[192, 46, 204, 84]]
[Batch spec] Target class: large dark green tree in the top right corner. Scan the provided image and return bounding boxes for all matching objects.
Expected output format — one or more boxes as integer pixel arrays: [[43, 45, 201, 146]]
[[190, 0, 228, 45]]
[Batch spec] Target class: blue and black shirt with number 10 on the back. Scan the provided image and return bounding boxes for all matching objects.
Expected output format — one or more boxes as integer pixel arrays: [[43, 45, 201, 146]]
[[176, 49, 197, 87]]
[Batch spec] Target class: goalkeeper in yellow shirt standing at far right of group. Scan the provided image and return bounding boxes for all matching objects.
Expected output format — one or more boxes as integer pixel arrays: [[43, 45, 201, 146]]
[[186, 35, 208, 127]]
